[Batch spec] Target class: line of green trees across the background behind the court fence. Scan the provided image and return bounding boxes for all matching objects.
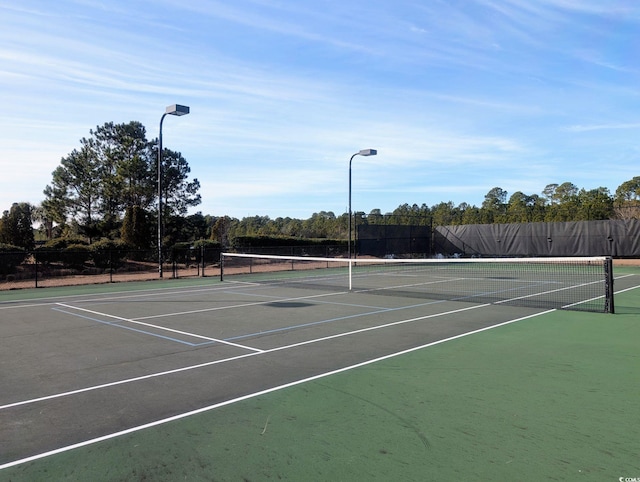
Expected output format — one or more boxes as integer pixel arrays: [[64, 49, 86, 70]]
[[0, 121, 640, 249]]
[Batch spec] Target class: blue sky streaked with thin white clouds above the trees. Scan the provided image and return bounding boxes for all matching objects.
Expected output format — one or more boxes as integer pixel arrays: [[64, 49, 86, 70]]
[[0, 0, 640, 218]]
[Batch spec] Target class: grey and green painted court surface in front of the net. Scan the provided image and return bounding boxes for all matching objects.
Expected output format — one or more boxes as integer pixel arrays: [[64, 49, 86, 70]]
[[0, 269, 640, 481]]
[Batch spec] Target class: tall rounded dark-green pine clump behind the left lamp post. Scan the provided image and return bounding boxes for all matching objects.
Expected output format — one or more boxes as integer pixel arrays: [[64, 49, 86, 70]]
[[42, 121, 200, 241]]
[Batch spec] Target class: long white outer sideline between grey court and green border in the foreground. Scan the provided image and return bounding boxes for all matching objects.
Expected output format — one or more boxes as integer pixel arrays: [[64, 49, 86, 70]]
[[0, 305, 556, 470]]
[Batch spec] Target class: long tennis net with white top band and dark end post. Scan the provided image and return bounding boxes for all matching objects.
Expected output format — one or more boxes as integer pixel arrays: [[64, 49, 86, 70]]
[[220, 253, 614, 313]]
